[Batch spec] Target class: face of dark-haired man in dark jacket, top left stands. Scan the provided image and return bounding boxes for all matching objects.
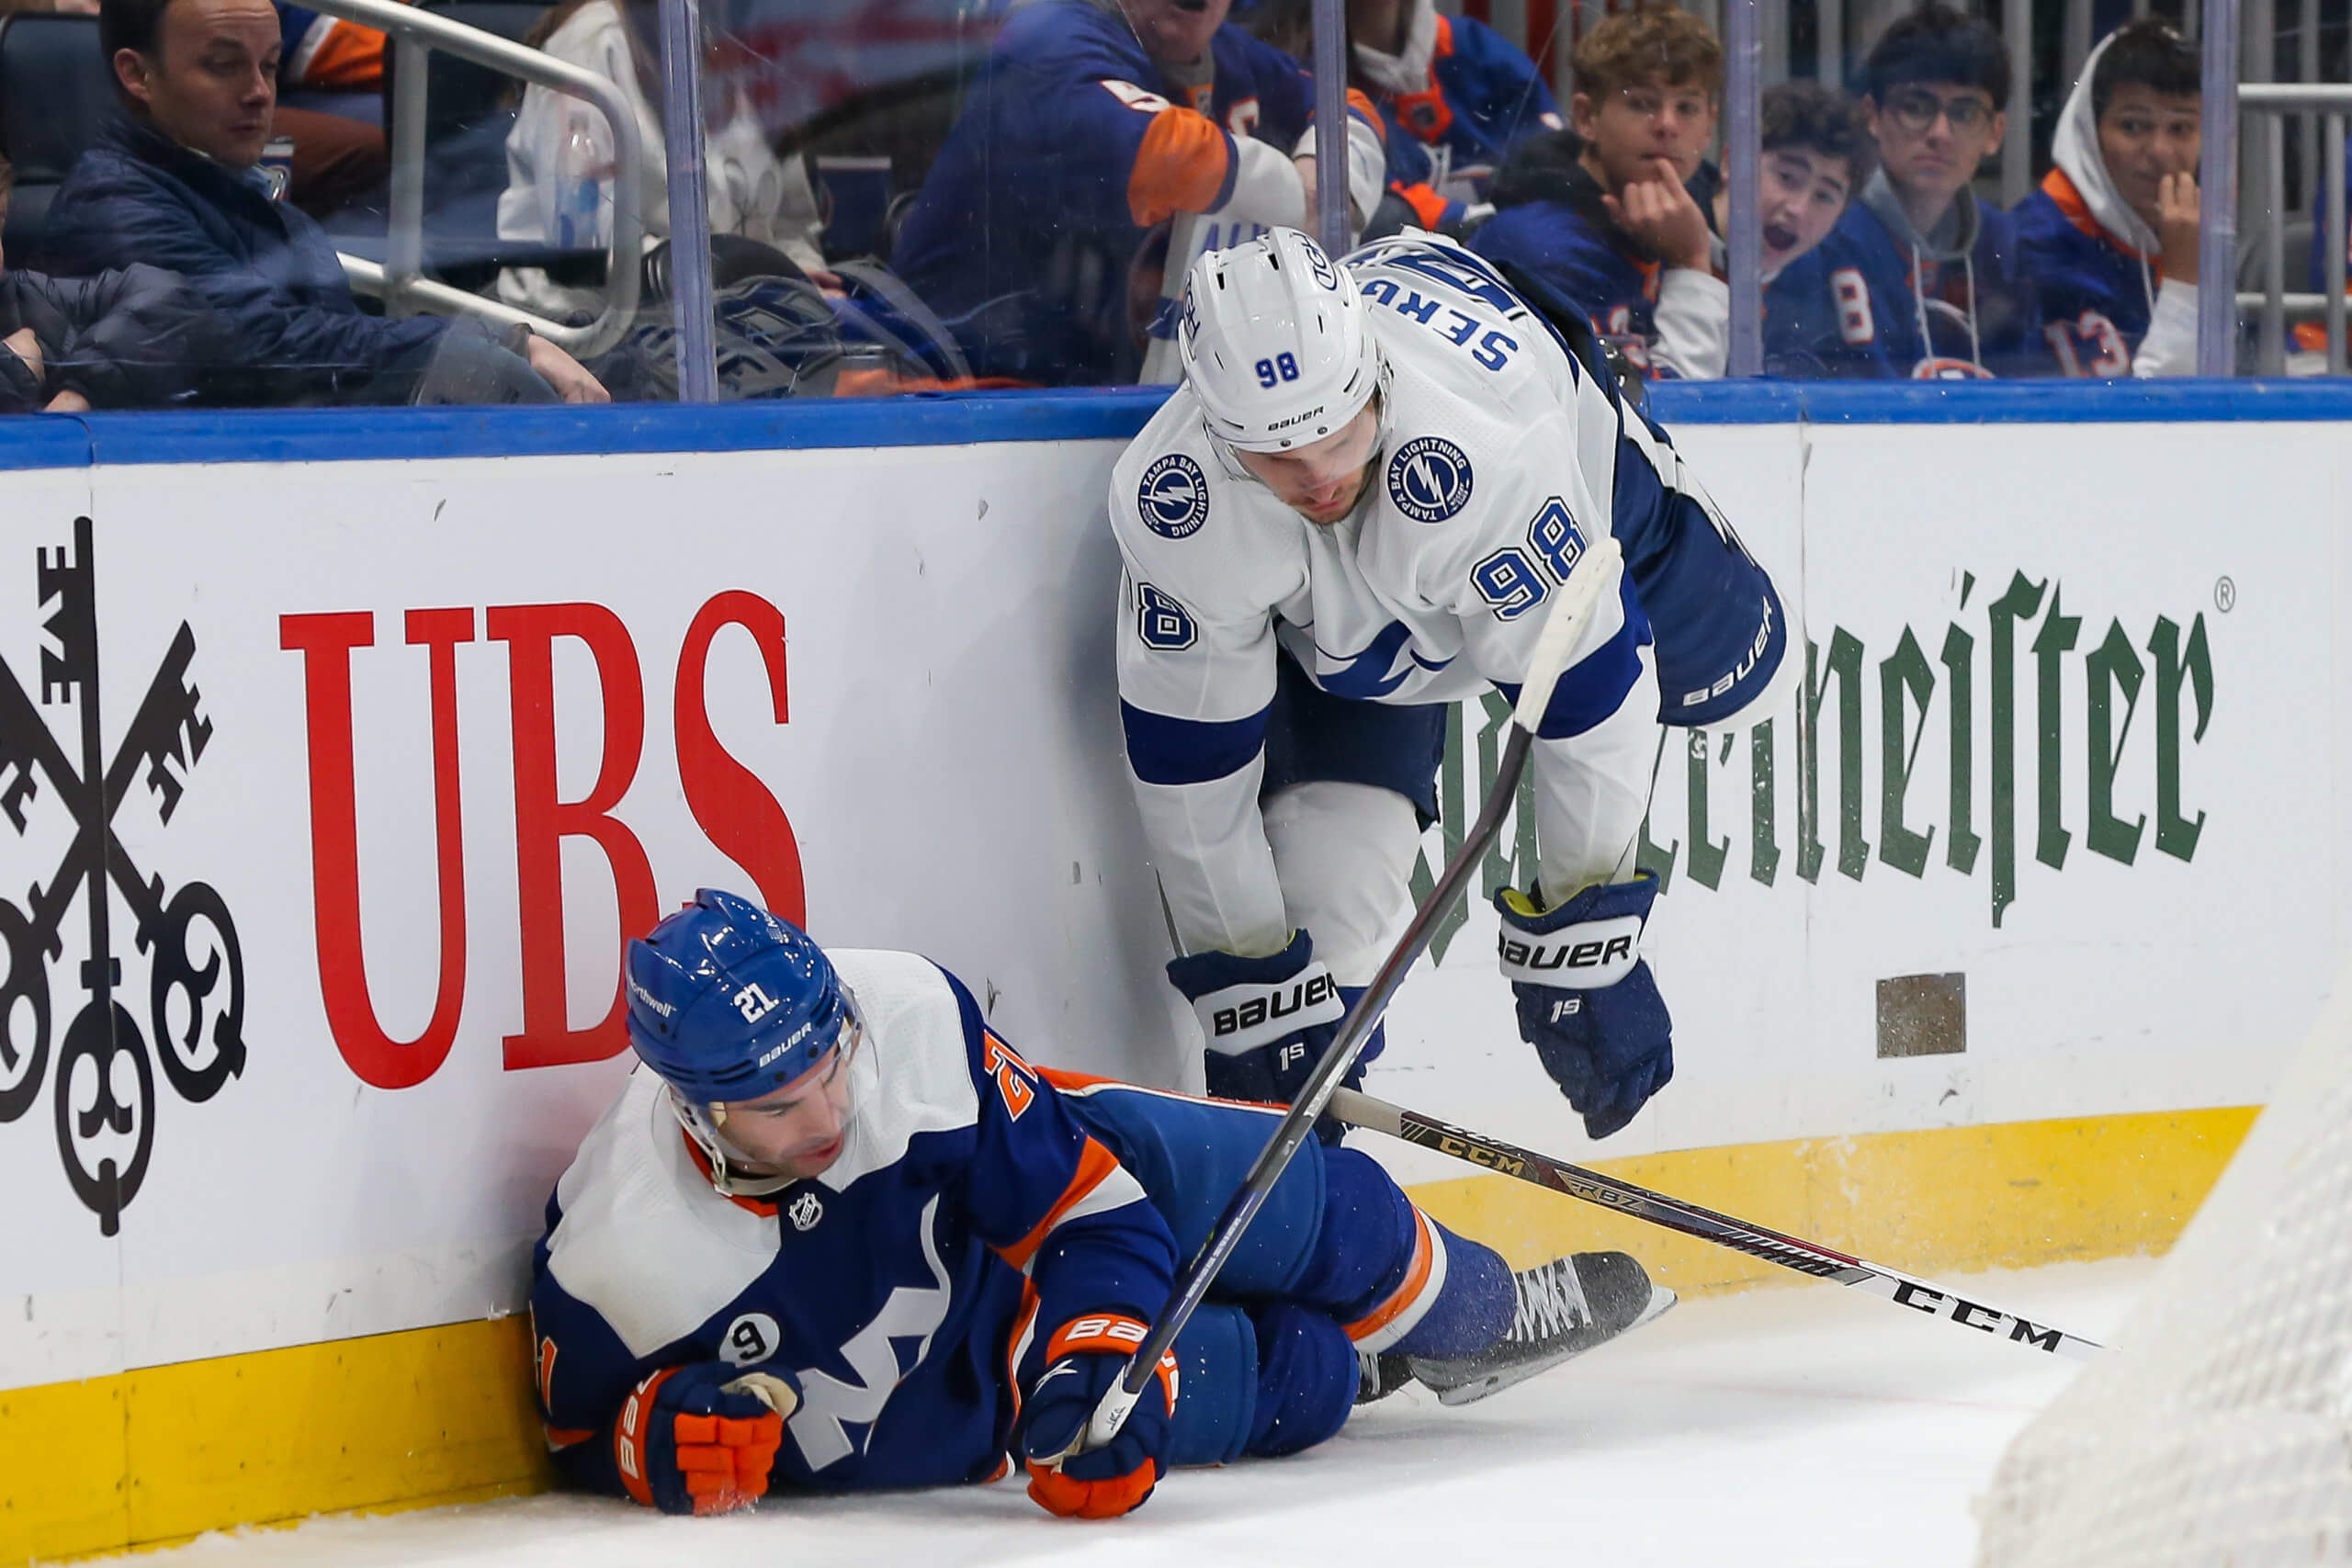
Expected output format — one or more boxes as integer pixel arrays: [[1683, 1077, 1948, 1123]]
[[113, 0, 280, 169]]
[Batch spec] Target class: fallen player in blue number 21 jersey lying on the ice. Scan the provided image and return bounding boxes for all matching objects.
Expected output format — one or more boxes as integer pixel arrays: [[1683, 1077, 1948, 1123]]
[[532, 888, 1675, 1518]]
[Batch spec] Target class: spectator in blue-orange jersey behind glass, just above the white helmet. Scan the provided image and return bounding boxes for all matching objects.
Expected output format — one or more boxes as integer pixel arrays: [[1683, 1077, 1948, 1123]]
[[1253, 0, 1564, 237]]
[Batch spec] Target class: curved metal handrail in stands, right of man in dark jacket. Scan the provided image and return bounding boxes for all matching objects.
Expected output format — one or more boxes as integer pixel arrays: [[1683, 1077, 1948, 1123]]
[[303, 0, 644, 360]]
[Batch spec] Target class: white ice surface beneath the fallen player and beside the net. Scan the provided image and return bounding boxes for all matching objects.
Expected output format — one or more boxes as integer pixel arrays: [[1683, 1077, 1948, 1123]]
[[86, 1260, 2154, 1568]]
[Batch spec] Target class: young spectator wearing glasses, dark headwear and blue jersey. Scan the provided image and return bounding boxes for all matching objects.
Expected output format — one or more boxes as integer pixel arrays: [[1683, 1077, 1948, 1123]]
[[1823, 0, 2055, 378]]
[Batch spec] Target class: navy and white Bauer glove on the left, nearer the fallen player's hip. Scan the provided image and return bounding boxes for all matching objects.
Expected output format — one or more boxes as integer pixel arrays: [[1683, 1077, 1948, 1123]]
[[1169, 931, 1348, 1105]]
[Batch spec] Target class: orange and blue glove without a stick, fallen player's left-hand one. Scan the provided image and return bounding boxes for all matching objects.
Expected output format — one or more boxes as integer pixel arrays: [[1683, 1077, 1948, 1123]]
[[612, 1361, 799, 1514]]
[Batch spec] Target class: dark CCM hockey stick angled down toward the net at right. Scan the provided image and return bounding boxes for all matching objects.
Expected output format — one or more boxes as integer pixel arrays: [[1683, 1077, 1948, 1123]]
[[1331, 1089, 2105, 1361]]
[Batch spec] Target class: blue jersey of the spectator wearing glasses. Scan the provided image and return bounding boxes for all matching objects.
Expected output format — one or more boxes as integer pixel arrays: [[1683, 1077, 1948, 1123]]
[[1818, 195, 2055, 378]]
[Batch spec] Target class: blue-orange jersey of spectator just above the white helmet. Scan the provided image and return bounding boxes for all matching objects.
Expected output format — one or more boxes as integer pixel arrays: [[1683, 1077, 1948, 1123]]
[[1374, 17, 1562, 231]]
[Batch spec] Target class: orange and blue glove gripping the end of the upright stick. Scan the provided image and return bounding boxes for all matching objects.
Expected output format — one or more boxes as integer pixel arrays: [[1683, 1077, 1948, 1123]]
[[1013, 1314, 1176, 1518]]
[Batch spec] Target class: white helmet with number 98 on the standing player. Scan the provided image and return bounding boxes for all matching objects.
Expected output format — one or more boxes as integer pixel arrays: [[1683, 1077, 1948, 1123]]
[[1176, 228, 1381, 451]]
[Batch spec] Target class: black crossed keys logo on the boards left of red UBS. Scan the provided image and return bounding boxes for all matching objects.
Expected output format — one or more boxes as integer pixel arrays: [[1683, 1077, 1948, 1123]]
[[0, 517, 244, 1236]]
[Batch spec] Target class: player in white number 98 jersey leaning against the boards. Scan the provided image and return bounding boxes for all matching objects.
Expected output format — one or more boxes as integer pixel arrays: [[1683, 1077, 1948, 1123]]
[[1110, 231, 1785, 1138]]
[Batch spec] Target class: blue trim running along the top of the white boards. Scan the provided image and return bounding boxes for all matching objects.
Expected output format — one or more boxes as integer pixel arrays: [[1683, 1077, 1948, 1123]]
[[0, 381, 2352, 470]]
